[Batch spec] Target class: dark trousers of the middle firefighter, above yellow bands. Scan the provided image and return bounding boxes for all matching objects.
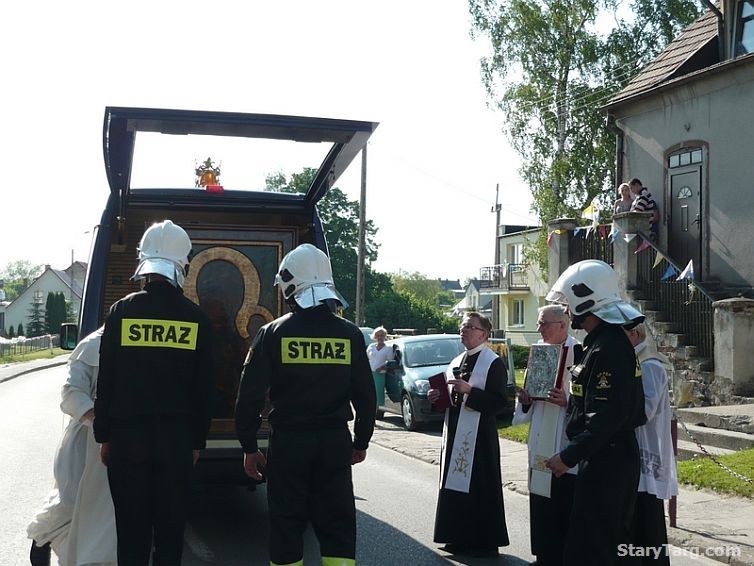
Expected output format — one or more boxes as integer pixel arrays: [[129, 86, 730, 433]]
[[267, 426, 356, 564]]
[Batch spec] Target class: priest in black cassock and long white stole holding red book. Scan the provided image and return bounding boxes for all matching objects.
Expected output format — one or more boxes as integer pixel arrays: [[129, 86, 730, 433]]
[[429, 312, 509, 556]]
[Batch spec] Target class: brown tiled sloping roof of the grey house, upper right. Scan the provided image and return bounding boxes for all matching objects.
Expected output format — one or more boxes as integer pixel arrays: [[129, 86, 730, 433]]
[[606, 10, 717, 107]]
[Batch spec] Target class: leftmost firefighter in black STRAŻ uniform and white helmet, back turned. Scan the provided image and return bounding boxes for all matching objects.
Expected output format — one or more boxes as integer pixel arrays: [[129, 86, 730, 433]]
[[94, 220, 212, 566]]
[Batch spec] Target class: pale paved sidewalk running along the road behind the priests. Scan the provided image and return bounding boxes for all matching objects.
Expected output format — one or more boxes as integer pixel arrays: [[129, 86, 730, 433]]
[[372, 416, 754, 566]]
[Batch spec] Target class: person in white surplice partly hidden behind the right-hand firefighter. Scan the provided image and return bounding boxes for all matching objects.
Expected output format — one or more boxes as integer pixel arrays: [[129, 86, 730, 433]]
[[626, 324, 678, 565]]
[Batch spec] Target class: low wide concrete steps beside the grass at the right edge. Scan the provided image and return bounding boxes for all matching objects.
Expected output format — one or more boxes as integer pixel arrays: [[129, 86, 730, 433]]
[[676, 400, 754, 460]]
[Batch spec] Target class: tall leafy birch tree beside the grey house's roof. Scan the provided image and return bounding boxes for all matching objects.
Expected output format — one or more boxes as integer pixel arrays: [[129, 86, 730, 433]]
[[469, 0, 699, 274]]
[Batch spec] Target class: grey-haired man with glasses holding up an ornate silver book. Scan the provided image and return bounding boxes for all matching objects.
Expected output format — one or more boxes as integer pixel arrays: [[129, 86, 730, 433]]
[[513, 305, 581, 566]]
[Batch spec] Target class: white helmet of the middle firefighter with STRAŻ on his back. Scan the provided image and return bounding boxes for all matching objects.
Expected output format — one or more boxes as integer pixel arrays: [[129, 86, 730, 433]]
[[275, 244, 348, 309]]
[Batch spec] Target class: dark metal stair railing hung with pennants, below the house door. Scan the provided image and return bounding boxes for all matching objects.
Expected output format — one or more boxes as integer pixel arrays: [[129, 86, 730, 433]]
[[637, 234, 715, 359]]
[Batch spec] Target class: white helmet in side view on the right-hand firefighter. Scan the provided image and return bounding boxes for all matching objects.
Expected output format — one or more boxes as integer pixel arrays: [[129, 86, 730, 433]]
[[546, 259, 644, 325]]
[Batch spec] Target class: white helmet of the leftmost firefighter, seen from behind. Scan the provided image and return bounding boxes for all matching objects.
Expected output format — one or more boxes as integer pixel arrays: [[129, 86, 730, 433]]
[[131, 220, 191, 287]]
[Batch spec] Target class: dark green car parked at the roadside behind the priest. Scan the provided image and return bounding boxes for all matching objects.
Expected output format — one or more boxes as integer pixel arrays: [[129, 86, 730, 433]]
[[377, 334, 515, 430]]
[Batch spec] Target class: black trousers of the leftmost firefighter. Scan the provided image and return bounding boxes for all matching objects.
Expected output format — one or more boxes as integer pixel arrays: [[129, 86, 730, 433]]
[[107, 416, 193, 566]]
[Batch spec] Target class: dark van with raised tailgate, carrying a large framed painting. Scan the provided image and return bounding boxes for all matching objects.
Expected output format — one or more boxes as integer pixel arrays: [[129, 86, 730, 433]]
[[67, 107, 377, 483]]
